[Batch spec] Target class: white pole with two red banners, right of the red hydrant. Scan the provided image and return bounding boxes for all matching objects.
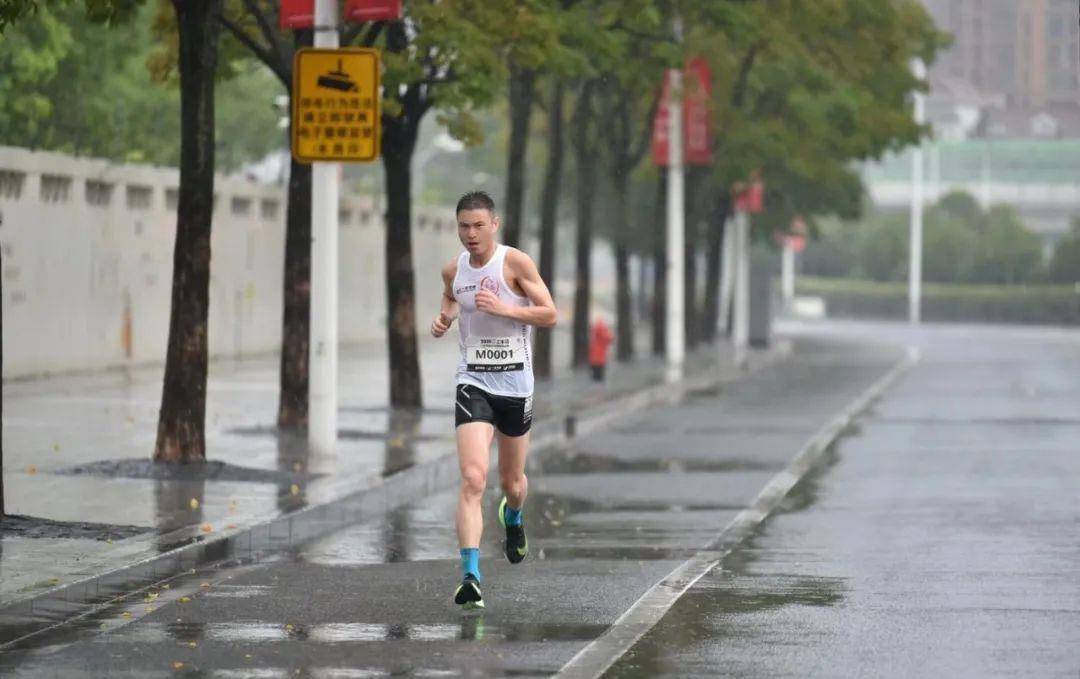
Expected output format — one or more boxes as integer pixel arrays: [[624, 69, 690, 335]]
[[664, 17, 686, 382]]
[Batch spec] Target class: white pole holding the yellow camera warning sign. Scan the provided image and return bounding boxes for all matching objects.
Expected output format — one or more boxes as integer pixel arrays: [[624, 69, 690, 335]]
[[308, 0, 341, 453]]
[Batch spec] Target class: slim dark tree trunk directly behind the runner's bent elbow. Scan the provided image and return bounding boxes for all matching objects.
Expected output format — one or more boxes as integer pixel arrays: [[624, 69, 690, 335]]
[[532, 80, 565, 379]]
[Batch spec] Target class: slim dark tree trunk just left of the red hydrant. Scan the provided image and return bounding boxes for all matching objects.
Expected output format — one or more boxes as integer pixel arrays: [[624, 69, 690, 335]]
[[572, 84, 596, 368]]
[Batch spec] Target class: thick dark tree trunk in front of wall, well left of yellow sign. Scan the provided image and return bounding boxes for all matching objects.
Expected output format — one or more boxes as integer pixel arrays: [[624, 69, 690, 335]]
[[153, 0, 221, 463]]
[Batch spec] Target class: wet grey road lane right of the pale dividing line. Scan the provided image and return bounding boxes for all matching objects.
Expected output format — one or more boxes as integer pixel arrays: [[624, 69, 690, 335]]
[[607, 325, 1080, 678]]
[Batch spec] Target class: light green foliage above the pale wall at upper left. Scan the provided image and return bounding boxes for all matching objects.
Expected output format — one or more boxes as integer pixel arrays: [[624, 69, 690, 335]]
[[0, 6, 285, 169]]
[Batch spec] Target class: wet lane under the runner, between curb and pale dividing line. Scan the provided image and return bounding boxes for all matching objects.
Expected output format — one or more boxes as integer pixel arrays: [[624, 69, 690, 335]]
[[0, 330, 899, 677]]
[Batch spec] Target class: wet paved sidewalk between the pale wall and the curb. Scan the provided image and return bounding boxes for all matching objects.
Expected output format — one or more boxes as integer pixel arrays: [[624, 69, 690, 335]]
[[0, 332, 778, 630]]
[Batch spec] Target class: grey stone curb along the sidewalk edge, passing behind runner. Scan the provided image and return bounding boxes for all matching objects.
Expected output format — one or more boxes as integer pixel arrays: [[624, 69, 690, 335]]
[[0, 340, 792, 651]]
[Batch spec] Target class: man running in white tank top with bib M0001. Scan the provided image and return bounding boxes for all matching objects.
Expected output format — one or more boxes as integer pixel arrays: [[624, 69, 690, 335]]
[[431, 191, 556, 610]]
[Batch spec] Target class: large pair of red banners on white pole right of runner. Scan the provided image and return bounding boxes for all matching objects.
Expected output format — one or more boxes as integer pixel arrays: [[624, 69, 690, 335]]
[[652, 57, 713, 167]]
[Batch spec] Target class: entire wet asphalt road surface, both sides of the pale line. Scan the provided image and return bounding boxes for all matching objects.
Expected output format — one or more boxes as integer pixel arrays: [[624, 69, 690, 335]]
[[0, 325, 1080, 678]]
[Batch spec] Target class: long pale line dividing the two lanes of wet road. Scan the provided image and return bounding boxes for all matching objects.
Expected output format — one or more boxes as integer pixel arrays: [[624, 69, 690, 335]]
[[555, 347, 919, 679]]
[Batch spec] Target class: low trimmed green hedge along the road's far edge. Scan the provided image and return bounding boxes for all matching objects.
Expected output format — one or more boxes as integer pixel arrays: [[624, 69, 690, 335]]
[[795, 277, 1080, 326]]
